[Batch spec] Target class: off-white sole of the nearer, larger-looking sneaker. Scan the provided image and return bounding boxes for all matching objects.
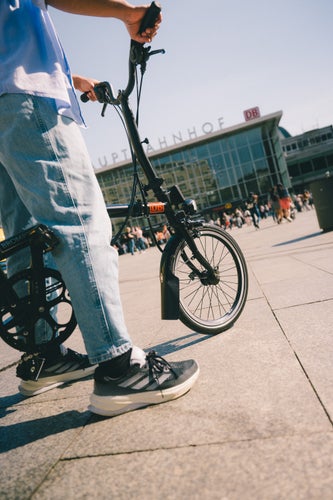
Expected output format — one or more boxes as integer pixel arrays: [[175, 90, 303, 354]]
[[88, 368, 200, 417]]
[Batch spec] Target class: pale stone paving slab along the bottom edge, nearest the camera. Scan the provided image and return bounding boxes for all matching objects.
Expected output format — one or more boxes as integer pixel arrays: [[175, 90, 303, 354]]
[[33, 433, 333, 500]]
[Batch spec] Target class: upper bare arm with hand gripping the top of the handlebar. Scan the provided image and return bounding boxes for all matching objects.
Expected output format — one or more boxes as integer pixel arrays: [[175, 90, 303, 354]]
[[46, 0, 162, 43]]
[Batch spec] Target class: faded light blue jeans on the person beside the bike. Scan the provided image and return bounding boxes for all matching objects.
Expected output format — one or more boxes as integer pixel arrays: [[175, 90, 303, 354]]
[[0, 94, 132, 363]]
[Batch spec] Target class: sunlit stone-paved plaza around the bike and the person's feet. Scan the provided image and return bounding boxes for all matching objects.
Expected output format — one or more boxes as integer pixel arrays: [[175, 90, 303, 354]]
[[0, 210, 333, 500]]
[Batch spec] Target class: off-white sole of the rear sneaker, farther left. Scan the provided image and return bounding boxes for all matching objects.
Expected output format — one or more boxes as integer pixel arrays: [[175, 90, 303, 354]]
[[18, 366, 96, 397]]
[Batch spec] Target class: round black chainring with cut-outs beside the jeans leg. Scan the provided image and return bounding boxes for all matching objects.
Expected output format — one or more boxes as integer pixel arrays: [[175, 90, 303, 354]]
[[0, 268, 77, 353]]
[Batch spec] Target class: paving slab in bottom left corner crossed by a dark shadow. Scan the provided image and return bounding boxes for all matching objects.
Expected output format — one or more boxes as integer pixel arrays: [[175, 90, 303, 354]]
[[0, 398, 91, 500]]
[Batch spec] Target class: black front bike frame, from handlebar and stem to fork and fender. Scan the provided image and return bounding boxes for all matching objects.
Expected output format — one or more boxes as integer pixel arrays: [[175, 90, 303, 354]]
[[91, 40, 219, 319]]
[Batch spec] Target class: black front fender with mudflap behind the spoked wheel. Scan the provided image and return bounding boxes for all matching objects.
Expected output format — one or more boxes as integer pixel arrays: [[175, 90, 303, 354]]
[[160, 235, 181, 320]]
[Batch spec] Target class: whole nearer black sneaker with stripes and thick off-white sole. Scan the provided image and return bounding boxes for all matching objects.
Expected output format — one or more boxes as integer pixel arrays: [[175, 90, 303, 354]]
[[89, 347, 199, 417]]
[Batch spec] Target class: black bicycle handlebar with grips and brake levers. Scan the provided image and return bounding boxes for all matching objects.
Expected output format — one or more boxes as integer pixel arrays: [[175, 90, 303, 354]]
[[80, 2, 161, 105]]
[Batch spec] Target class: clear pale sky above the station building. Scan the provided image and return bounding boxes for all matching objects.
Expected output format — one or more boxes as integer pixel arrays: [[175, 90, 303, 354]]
[[50, 0, 333, 168]]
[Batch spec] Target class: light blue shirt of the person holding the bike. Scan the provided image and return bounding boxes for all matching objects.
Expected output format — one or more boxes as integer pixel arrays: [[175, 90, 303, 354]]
[[0, 0, 83, 124]]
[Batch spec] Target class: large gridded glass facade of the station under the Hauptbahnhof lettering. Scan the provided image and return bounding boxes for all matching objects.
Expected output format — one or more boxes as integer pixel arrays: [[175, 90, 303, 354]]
[[96, 113, 290, 217]]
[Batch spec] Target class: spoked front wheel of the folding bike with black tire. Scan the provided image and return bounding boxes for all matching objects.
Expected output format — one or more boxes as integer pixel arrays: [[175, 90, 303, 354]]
[[171, 224, 248, 335]]
